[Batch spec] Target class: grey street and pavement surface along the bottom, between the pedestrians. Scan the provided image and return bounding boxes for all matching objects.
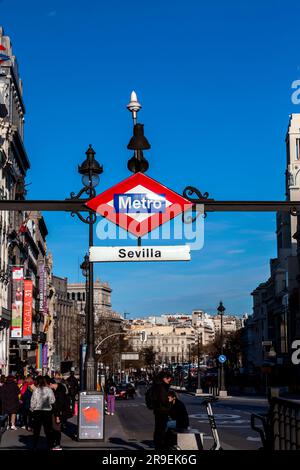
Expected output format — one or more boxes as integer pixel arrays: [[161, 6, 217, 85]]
[[0, 387, 267, 450]]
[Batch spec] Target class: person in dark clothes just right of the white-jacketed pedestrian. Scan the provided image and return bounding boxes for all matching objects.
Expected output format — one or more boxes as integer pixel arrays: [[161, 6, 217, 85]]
[[49, 379, 68, 450]]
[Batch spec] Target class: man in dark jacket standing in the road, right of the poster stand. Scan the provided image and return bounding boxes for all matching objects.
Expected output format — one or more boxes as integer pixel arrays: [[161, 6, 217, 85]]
[[152, 371, 172, 451]]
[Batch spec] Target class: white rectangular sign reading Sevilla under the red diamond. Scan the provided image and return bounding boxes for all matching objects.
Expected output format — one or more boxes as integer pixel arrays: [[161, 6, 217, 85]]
[[89, 245, 191, 262]]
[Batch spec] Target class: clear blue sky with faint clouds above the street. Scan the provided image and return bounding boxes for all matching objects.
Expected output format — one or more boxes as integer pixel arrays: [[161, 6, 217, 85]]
[[0, 0, 300, 317]]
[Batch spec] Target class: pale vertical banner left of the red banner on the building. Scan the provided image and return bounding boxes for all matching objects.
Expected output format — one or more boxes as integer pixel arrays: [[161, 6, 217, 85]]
[[10, 266, 24, 338]]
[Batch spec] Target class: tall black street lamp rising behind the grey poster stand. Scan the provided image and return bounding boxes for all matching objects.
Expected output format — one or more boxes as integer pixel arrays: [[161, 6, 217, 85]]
[[71, 145, 103, 391]]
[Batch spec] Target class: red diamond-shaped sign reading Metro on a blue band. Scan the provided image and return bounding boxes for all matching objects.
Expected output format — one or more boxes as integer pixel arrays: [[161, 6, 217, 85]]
[[86, 173, 192, 237]]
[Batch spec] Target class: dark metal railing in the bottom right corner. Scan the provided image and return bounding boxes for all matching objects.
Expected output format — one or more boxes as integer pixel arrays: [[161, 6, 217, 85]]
[[251, 398, 300, 450]]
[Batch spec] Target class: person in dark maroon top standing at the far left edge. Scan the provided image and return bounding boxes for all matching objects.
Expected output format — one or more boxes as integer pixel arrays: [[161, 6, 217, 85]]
[[1, 375, 20, 431]]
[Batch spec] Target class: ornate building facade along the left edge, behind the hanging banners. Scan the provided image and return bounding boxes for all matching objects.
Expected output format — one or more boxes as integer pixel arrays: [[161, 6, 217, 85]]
[[0, 27, 50, 374]]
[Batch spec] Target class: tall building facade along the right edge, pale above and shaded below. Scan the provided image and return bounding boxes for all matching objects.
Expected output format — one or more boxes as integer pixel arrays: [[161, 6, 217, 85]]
[[245, 114, 300, 383]]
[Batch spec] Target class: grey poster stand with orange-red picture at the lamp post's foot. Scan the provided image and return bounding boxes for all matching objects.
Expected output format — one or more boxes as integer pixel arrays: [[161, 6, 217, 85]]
[[78, 392, 104, 440]]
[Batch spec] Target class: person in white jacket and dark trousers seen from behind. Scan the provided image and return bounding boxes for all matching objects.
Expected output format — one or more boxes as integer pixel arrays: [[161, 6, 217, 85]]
[[30, 375, 55, 450]]
